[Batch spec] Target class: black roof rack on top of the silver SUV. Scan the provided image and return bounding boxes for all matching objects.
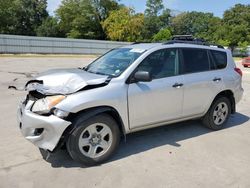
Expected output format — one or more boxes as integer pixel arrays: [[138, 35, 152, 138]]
[[163, 35, 224, 49]]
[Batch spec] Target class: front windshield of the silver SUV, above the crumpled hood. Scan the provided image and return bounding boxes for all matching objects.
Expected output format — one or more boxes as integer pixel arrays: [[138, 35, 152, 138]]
[[85, 48, 145, 77]]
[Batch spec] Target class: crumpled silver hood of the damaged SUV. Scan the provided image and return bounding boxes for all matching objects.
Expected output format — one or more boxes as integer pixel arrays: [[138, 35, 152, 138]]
[[26, 69, 108, 95]]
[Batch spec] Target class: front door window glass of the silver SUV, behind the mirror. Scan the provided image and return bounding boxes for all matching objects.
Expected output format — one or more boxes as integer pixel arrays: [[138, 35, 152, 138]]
[[137, 49, 179, 79]]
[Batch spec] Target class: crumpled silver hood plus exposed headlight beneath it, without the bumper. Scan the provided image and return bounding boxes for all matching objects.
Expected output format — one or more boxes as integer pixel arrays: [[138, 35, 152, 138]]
[[25, 69, 110, 118]]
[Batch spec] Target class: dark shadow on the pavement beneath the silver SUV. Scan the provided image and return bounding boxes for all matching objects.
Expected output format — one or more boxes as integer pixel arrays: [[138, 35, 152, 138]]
[[44, 113, 249, 168]]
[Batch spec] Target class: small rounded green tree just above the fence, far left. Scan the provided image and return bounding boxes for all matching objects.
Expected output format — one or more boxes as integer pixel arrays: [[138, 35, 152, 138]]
[[36, 17, 60, 37]]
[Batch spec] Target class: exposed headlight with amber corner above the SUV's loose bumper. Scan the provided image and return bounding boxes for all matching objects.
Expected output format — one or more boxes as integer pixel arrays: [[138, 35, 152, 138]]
[[31, 95, 66, 114]]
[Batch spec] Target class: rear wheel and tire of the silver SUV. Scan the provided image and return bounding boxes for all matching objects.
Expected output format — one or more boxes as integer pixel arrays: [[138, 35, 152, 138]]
[[202, 97, 232, 130]]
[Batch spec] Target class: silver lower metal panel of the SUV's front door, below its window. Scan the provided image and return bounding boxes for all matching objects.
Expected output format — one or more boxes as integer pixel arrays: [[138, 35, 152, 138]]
[[128, 76, 183, 129]]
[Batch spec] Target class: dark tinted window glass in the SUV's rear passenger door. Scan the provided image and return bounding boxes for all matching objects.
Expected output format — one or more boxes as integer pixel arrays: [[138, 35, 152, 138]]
[[182, 48, 210, 73]]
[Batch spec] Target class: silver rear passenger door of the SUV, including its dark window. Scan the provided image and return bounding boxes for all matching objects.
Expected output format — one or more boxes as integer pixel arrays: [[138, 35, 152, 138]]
[[181, 48, 223, 117]]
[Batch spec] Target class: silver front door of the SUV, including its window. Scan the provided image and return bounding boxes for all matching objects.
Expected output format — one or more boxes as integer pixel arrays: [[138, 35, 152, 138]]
[[128, 49, 183, 129]]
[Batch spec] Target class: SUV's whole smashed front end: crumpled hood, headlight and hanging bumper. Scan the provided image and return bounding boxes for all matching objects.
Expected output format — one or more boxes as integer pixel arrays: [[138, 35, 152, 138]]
[[18, 69, 110, 152]]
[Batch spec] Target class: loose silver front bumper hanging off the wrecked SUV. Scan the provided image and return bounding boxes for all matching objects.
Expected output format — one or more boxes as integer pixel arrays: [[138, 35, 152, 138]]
[[17, 101, 71, 151]]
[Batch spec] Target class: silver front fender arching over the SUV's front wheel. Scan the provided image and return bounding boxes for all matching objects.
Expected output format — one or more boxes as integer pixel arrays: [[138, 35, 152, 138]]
[[55, 79, 129, 132]]
